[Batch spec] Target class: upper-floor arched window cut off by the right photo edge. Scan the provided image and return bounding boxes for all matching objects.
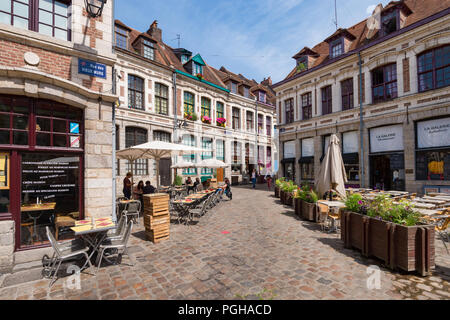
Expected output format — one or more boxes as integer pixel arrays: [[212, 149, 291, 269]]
[[417, 45, 450, 92]]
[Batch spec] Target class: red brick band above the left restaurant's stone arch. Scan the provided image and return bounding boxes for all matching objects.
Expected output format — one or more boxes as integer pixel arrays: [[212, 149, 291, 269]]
[[0, 40, 72, 80]]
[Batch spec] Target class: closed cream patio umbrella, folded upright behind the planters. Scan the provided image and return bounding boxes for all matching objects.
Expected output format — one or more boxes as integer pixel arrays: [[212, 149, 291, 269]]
[[315, 134, 347, 198]]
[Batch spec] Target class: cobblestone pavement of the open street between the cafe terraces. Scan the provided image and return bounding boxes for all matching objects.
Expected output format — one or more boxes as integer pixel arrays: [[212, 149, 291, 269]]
[[0, 186, 450, 299]]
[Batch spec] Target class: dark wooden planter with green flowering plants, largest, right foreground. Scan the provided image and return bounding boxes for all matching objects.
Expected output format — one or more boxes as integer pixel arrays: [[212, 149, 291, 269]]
[[341, 194, 434, 276]]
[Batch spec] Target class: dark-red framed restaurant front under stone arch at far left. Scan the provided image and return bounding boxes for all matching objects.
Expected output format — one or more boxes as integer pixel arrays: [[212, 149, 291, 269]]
[[0, 95, 84, 250]]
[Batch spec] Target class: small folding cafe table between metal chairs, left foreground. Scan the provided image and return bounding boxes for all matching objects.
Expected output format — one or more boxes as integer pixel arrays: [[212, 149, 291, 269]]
[[71, 217, 116, 269]]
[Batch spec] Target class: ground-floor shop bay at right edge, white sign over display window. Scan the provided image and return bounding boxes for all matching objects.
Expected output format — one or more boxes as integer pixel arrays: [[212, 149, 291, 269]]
[[415, 117, 450, 193]]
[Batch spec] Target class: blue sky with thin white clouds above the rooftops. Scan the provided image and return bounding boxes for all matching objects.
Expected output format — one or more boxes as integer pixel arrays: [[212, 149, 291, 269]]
[[115, 0, 389, 83]]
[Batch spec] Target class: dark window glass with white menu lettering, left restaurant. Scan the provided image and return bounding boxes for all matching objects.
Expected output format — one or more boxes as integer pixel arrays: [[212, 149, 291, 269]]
[[21, 153, 80, 213]]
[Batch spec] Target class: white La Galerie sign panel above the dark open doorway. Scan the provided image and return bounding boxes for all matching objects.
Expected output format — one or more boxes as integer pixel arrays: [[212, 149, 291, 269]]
[[370, 124, 403, 153]]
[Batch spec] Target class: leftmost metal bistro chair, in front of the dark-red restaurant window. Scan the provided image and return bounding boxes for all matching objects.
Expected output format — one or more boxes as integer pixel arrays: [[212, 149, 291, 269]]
[[44, 226, 92, 287]]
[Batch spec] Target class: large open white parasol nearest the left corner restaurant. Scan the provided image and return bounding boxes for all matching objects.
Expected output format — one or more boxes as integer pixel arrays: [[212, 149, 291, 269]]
[[116, 141, 205, 188]]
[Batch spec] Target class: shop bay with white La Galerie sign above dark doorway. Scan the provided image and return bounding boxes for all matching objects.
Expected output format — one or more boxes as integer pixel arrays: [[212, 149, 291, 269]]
[[369, 124, 405, 191]]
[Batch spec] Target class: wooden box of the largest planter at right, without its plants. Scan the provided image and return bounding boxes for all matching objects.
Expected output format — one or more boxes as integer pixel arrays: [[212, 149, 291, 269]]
[[341, 211, 435, 276]]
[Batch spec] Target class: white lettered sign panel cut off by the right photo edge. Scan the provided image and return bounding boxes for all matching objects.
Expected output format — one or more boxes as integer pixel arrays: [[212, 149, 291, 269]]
[[417, 117, 450, 149]]
